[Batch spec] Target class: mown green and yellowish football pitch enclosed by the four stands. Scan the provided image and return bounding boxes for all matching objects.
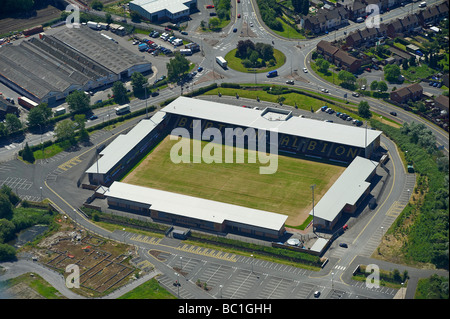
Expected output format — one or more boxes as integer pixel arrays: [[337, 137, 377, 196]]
[[122, 136, 345, 226]]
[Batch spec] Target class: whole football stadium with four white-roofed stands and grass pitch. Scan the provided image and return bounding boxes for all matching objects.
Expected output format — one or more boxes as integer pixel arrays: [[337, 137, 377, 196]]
[[86, 97, 381, 239]]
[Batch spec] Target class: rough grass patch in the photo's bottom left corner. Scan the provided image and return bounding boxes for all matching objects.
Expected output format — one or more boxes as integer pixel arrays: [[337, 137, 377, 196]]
[[2, 273, 67, 299]]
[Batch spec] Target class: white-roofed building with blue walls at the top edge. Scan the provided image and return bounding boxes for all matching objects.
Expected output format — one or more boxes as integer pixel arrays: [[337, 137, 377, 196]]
[[129, 0, 197, 22]]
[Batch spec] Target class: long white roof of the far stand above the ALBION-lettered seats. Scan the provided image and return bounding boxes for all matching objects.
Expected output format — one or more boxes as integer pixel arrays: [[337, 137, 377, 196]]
[[163, 96, 382, 148]]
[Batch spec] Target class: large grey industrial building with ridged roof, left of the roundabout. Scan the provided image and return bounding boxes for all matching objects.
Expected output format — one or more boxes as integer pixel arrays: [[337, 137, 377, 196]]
[[0, 25, 151, 104]]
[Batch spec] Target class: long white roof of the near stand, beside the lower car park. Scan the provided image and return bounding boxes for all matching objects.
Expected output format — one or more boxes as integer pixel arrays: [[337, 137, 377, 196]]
[[105, 182, 288, 231]]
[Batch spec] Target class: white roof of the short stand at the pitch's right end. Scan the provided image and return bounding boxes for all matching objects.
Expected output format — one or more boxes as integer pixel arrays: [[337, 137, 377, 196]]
[[310, 156, 378, 222]]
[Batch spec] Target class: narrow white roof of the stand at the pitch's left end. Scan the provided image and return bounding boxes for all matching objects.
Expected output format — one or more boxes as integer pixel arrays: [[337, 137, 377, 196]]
[[86, 111, 165, 174]]
